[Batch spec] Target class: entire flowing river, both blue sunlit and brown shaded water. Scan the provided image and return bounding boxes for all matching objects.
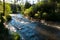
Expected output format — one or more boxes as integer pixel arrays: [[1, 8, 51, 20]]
[[8, 14, 60, 40]]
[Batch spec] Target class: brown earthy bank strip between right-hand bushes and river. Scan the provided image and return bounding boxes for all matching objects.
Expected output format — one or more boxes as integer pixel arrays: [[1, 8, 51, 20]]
[[24, 16, 60, 30]]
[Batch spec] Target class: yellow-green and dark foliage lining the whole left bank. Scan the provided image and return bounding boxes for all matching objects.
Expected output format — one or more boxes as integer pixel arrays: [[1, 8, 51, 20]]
[[0, 2, 20, 40]]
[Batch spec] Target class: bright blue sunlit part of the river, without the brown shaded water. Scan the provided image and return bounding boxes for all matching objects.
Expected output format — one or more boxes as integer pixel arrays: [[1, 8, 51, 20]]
[[9, 14, 43, 40]]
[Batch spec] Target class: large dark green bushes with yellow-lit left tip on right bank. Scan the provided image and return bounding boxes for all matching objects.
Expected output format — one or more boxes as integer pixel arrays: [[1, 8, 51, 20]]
[[24, 0, 60, 21]]
